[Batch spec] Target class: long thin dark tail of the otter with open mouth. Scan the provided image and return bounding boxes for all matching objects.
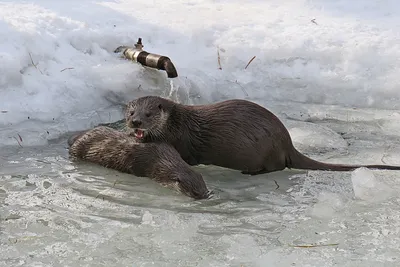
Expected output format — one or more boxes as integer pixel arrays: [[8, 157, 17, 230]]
[[286, 148, 400, 171]]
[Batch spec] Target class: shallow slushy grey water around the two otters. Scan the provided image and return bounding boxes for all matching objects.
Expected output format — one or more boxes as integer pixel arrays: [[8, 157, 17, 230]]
[[0, 106, 400, 267]]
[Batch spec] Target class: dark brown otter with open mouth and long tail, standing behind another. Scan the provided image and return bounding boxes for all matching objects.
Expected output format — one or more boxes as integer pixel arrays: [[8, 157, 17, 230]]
[[125, 96, 400, 175]]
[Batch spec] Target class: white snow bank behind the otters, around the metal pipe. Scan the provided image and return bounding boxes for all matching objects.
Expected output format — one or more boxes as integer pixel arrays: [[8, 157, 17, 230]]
[[0, 0, 400, 145]]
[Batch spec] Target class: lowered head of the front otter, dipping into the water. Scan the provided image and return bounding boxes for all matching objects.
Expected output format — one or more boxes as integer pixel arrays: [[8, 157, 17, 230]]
[[174, 171, 213, 199]]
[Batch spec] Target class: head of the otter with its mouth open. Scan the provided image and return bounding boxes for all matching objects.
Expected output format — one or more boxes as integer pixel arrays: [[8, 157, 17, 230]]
[[125, 96, 171, 142]]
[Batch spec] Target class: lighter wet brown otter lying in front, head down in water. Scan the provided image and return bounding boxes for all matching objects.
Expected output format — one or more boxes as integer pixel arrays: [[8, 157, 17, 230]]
[[68, 126, 211, 199]]
